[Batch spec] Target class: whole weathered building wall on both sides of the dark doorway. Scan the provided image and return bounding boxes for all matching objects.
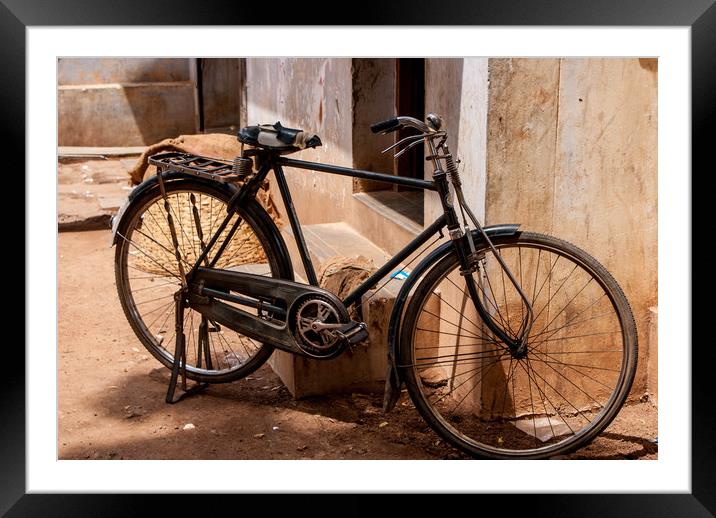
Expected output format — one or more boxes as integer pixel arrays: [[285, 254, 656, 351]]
[[247, 58, 658, 402]]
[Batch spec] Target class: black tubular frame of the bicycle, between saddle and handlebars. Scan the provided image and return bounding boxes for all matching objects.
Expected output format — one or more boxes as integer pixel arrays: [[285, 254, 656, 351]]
[[191, 150, 469, 312]]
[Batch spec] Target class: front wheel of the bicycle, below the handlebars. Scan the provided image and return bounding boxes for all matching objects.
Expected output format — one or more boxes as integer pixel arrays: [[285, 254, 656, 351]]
[[398, 232, 637, 458]]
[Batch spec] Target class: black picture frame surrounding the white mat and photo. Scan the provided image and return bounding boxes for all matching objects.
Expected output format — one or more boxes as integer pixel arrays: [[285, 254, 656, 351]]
[[0, 0, 716, 517]]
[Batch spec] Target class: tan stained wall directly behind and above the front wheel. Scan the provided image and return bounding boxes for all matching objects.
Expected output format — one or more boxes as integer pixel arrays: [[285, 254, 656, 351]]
[[486, 59, 657, 394]]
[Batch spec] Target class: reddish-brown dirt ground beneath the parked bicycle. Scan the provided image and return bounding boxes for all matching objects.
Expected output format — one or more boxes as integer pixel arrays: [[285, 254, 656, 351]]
[[58, 230, 657, 460]]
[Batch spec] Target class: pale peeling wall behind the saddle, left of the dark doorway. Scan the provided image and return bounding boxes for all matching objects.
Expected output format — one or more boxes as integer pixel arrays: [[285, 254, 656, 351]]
[[246, 58, 353, 225]]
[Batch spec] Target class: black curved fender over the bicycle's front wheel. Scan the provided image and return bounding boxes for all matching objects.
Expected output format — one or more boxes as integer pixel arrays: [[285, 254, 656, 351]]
[[383, 224, 520, 412]]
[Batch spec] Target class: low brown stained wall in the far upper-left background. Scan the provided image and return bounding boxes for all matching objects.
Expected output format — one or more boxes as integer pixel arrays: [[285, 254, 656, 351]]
[[57, 58, 197, 147]]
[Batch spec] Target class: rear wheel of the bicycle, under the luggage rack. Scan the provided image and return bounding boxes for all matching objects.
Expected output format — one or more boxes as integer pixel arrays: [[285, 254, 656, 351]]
[[115, 179, 292, 383]]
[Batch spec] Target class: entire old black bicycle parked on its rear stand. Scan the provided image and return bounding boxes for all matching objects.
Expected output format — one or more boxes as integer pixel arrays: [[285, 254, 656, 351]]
[[112, 114, 637, 459]]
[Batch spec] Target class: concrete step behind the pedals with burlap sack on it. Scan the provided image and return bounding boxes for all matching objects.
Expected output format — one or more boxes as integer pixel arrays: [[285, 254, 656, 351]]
[[269, 222, 414, 398]]
